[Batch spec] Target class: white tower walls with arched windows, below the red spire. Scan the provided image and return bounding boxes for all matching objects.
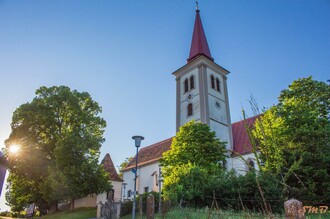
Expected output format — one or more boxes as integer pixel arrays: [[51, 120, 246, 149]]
[[173, 56, 233, 169]]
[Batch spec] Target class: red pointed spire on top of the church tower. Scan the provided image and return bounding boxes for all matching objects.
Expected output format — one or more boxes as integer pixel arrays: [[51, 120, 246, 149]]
[[187, 8, 214, 62]]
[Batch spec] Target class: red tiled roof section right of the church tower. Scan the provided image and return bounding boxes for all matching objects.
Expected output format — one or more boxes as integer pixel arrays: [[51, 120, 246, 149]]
[[232, 115, 259, 156]]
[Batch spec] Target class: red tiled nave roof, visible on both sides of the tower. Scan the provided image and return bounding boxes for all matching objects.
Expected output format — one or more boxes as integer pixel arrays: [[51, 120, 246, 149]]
[[124, 116, 259, 170]]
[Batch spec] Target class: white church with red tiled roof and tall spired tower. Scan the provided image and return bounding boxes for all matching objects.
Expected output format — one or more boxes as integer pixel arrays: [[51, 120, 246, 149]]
[[121, 8, 257, 200]]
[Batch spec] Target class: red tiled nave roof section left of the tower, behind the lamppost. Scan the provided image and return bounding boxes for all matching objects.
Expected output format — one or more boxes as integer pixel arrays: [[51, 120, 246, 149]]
[[124, 137, 173, 170]]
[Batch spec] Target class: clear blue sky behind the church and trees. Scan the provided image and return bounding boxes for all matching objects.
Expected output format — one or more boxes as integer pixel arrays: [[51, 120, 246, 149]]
[[0, 0, 330, 210]]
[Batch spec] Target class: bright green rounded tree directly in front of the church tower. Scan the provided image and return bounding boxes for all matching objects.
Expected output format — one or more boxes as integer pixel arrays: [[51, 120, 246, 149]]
[[161, 121, 226, 203]]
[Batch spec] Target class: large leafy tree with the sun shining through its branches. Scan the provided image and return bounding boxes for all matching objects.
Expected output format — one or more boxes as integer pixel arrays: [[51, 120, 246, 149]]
[[5, 86, 110, 212]]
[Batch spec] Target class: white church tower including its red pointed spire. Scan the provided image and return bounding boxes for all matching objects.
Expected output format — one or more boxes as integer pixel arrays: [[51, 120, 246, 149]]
[[173, 8, 233, 166]]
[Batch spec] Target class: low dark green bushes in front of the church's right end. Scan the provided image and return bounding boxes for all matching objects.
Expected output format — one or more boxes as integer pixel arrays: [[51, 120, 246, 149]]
[[170, 171, 284, 213]]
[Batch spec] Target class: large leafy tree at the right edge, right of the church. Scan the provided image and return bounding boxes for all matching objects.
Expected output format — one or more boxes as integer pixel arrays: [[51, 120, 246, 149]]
[[254, 77, 330, 203]]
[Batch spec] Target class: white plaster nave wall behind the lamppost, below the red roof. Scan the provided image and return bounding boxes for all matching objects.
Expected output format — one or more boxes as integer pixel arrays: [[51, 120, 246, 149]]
[[123, 162, 159, 199]]
